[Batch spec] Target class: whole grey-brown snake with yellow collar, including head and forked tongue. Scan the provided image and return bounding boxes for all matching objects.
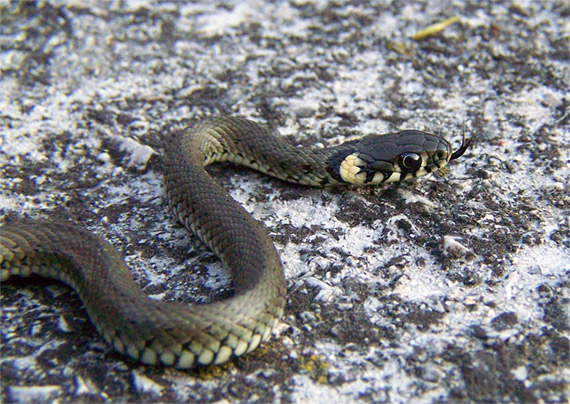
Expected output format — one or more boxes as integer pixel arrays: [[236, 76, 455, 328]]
[[0, 117, 468, 369]]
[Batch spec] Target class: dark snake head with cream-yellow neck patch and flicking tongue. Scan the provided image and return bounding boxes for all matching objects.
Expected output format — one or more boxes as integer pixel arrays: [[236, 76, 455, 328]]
[[329, 130, 470, 185]]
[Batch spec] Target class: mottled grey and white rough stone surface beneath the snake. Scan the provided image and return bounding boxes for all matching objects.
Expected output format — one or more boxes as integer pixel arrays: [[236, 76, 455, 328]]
[[0, 0, 570, 402]]
